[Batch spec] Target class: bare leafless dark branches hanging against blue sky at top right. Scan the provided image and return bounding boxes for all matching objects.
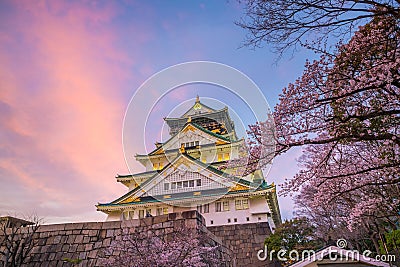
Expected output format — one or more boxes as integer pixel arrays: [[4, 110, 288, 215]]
[[237, 0, 400, 55]]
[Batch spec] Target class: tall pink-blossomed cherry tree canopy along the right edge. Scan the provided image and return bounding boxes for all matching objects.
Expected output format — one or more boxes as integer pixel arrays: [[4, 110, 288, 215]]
[[275, 14, 400, 220]]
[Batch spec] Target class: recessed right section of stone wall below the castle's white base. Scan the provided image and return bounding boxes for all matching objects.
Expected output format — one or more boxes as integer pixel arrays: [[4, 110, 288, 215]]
[[207, 222, 279, 267]]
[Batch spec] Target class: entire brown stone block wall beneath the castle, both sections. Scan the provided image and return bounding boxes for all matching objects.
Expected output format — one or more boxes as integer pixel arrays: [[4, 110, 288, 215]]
[[0, 211, 274, 267]]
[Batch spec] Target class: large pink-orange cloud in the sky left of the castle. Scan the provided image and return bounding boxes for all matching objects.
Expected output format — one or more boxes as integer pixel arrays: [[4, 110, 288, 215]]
[[0, 1, 150, 223]]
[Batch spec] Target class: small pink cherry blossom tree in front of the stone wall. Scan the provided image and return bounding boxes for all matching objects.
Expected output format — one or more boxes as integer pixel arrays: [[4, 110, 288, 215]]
[[105, 226, 224, 267]]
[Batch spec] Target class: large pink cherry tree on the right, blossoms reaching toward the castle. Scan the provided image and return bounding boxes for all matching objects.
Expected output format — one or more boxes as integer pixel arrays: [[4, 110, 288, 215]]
[[242, 8, 400, 250]]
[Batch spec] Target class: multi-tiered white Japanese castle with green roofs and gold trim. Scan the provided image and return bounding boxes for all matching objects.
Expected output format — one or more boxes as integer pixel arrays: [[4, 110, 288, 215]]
[[96, 97, 281, 230]]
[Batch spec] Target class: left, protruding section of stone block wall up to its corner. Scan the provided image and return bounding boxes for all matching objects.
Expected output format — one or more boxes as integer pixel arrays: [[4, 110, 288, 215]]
[[0, 211, 234, 267]]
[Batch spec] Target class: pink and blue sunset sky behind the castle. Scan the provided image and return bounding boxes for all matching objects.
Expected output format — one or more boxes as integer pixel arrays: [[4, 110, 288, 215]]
[[0, 0, 316, 223]]
